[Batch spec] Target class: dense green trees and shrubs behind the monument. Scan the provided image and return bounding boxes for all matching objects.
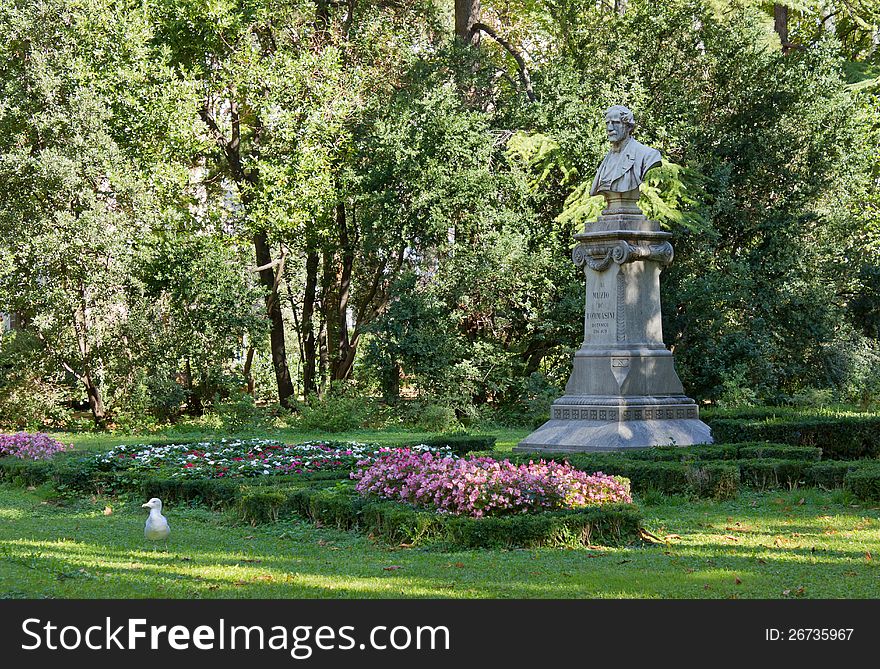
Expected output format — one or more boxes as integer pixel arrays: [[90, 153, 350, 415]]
[[0, 0, 880, 431]]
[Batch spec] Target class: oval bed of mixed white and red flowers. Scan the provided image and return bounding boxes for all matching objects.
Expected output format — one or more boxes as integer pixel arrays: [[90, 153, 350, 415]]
[[96, 439, 448, 478]]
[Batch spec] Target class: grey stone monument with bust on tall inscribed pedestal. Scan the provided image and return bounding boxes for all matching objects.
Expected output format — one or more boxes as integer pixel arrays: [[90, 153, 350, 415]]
[[514, 105, 712, 451]]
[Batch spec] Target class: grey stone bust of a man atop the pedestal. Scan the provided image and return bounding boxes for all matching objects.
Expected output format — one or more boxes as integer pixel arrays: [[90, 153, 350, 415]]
[[590, 105, 661, 198]]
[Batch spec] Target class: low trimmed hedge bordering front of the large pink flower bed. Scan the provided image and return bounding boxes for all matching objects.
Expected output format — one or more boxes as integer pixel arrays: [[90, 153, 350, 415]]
[[290, 483, 641, 548]]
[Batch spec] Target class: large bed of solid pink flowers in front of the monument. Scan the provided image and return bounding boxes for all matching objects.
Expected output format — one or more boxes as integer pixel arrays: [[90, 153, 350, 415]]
[[351, 449, 632, 518]]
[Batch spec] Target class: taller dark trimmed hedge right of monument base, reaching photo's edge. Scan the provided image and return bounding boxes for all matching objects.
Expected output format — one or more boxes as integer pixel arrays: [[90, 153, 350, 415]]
[[710, 415, 880, 460]]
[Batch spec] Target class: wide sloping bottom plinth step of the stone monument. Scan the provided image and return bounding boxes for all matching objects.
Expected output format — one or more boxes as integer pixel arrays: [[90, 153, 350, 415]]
[[513, 418, 712, 453]]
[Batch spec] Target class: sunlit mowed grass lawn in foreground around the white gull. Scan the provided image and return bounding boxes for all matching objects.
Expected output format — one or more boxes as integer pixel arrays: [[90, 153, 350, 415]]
[[0, 485, 880, 598]]
